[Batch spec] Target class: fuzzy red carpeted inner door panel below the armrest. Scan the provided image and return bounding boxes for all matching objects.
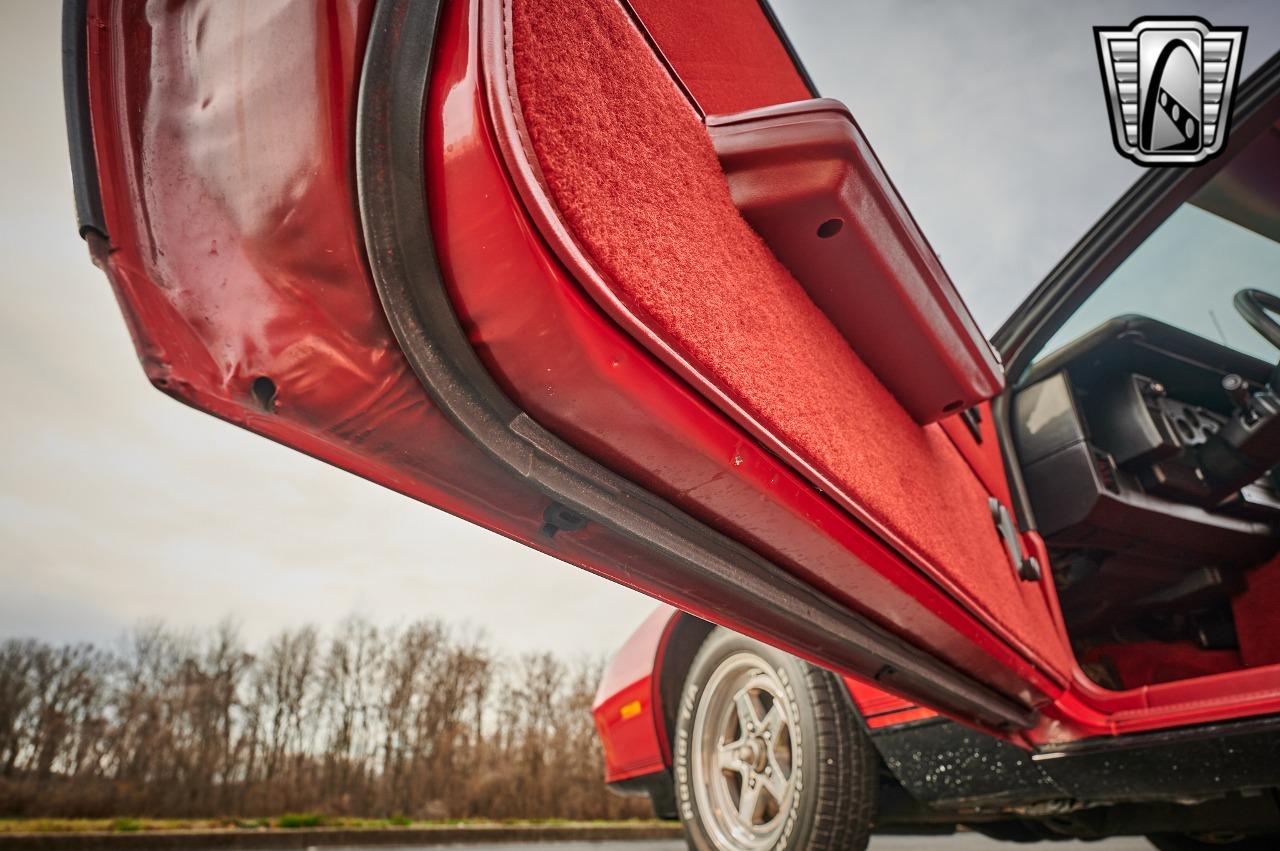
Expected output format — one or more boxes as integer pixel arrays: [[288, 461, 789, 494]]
[[486, 0, 1068, 671]]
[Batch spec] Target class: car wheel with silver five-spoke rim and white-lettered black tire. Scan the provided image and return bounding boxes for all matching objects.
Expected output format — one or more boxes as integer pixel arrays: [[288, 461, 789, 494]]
[[672, 628, 879, 851]]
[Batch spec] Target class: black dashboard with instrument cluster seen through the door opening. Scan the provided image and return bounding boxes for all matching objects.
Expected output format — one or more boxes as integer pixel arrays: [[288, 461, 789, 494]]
[[1012, 316, 1280, 637]]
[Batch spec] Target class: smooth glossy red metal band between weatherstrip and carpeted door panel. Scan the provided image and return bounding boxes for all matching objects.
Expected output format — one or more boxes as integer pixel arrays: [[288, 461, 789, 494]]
[[460, 0, 1065, 691]]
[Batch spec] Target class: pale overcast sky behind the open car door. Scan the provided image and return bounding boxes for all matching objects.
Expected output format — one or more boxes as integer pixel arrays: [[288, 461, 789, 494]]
[[0, 0, 1280, 655]]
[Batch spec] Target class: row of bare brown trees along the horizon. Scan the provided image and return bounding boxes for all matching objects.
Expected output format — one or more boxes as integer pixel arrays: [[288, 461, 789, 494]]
[[0, 617, 648, 819]]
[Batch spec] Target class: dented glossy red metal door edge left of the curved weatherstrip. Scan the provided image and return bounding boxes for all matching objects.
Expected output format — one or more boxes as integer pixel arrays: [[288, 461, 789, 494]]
[[77, 0, 627, 604]]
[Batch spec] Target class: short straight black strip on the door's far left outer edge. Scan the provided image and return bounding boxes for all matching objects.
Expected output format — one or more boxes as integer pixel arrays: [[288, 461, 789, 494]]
[[61, 0, 106, 239]]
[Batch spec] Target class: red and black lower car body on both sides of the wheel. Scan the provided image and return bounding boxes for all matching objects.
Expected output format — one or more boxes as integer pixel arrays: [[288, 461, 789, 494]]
[[593, 605, 1280, 819]]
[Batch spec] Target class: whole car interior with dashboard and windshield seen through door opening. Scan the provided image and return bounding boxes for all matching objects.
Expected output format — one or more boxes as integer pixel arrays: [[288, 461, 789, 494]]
[[1012, 120, 1280, 688]]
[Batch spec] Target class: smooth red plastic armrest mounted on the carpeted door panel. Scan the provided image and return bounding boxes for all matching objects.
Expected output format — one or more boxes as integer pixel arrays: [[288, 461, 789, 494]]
[[707, 99, 1004, 424]]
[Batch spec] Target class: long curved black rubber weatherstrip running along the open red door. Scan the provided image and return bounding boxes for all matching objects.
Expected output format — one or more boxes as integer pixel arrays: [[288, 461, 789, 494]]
[[356, 0, 1038, 728]]
